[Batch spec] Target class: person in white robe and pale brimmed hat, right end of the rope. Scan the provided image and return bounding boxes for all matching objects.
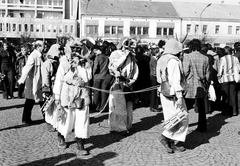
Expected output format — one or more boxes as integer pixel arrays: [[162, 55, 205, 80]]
[[156, 39, 188, 153]]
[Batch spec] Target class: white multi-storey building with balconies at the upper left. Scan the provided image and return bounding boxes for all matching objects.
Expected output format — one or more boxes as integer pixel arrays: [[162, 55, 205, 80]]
[[0, 0, 77, 40]]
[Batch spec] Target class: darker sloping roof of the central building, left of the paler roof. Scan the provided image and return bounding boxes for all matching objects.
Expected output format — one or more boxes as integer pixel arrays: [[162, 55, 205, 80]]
[[81, 0, 179, 18]]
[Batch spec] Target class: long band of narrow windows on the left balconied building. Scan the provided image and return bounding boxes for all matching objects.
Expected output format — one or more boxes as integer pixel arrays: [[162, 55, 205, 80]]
[[0, 23, 74, 33]]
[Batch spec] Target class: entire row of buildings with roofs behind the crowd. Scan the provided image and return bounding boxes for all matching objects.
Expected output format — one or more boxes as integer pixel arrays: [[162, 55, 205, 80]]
[[0, 0, 240, 46]]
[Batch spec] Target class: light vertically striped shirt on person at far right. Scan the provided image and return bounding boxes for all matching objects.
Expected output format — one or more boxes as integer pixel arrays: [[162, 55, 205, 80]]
[[218, 55, 239, 83]]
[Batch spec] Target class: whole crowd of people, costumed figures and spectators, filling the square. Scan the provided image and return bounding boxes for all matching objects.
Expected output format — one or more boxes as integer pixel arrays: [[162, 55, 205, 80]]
[[0, 35, 240, 155]]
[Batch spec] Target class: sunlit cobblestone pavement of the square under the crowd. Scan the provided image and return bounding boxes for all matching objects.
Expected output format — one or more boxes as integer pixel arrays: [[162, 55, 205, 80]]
[[0, 92, 240, 166]]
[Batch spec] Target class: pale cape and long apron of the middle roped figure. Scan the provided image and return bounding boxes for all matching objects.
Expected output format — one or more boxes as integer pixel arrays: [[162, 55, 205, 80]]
[[108, 46, 139, 134]]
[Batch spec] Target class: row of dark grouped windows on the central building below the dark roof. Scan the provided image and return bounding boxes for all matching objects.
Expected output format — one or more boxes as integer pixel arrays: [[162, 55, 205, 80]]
[[86, 25, 174, 36]]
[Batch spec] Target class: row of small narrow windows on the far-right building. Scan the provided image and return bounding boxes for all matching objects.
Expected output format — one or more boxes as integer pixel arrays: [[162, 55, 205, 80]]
[[187, 24, 240, 35]]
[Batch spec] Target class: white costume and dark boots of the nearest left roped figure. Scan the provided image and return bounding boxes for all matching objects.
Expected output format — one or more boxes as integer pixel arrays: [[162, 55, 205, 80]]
[[53, 56, 92, 155]]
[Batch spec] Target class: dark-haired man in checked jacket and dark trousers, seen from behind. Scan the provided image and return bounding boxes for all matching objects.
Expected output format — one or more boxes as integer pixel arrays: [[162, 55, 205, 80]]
[[183, 39, 210, 132]]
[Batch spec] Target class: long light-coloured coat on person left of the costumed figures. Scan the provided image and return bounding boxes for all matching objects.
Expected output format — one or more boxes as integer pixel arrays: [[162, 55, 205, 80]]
[[19, 50, 43, 102]]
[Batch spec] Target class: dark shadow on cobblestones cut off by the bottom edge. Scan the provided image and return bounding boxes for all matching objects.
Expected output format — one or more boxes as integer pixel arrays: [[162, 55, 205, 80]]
[[19, 152, 117, 166]]
